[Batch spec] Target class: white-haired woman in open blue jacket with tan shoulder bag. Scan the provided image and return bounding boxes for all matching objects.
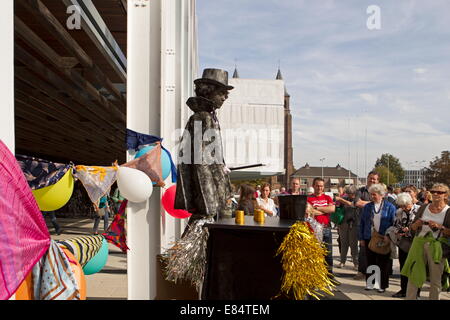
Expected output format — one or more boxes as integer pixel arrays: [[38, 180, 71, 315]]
[[358, 184, 396, 293]]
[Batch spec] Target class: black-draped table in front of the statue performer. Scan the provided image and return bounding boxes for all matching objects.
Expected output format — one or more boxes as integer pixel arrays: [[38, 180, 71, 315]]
[[202, 216, 296, 300]]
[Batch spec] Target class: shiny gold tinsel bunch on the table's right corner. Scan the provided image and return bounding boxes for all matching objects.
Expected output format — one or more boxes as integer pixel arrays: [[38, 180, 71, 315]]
[[277, 221, 335, 300]]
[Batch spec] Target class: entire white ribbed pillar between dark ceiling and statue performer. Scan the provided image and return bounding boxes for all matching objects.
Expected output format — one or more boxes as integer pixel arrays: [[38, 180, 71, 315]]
[[127, 0, 198, 299]]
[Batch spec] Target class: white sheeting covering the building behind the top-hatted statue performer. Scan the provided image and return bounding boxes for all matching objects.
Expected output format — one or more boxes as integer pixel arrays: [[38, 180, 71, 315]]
[[218, 78, 284, 174]]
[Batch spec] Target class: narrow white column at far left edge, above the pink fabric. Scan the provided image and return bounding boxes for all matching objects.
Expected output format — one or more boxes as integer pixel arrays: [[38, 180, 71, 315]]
[[0, 0, 15, 153]]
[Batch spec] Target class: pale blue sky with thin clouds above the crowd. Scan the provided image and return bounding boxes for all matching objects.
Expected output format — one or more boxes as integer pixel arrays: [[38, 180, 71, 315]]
[[197, 0, 450, 175]]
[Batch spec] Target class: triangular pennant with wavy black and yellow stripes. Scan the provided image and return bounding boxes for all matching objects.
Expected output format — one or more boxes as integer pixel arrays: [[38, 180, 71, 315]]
[[58, 235, 103, 267]]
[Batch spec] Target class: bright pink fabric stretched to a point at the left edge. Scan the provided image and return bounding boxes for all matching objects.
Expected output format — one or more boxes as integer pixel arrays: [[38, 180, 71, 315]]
[[0, 140, 50, 300]]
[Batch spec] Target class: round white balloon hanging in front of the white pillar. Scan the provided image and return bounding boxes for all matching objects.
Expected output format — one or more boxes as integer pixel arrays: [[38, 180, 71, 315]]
[[117, 167, 153, 202]]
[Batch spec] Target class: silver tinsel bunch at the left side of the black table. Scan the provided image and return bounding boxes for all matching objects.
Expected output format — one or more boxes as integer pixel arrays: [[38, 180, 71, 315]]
[[163, 218, 214, 292]]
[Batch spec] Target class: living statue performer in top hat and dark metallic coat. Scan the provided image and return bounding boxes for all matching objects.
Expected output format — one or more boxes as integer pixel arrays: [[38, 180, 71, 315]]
[[175, 69, 233, 225]]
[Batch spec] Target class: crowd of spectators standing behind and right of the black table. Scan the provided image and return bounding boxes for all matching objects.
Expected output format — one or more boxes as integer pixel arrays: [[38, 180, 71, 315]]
[[234, 171, 450, 300]]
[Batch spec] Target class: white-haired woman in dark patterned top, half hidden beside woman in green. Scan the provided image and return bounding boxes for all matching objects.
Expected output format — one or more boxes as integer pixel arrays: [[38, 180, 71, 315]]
[[392, 191, 420, 298]]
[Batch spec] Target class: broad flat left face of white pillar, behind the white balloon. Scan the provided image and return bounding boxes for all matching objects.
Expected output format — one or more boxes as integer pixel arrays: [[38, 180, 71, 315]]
[[127, 0, 161, 300]]
